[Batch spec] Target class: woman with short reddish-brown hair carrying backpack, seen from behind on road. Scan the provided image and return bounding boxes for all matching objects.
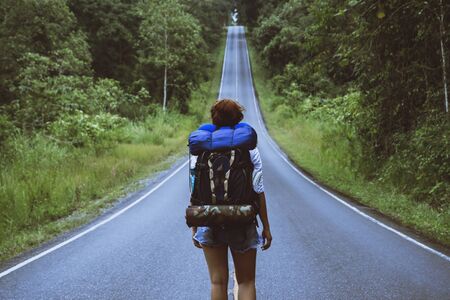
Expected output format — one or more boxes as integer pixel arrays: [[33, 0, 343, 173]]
[[188, 99, 272, 299]]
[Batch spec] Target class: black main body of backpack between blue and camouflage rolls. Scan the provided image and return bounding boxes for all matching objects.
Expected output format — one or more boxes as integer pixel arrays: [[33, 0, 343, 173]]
[[191, 148, 257, 211]]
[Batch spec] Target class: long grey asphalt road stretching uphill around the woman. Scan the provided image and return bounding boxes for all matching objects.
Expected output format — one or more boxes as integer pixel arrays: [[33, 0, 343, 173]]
[[0, 26, 450, 299]]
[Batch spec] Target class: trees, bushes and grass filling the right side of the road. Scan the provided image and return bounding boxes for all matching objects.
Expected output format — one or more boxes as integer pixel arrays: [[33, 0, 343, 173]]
[[240, 0, 450, 246]]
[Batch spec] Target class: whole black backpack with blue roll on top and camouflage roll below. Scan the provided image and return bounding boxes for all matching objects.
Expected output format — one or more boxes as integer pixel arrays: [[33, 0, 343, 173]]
[[186, 123, 258, 227]]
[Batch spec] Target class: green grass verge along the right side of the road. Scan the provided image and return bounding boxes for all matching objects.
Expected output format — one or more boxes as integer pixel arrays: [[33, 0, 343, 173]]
[[249, 43, 450, 247]]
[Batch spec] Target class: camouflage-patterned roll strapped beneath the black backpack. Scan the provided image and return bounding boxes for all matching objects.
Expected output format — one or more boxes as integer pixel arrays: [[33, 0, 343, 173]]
[[186, 205, 256, 227]]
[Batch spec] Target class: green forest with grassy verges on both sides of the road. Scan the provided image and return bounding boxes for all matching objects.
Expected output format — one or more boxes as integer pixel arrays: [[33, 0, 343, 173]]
[[0, 0, 450, 260]]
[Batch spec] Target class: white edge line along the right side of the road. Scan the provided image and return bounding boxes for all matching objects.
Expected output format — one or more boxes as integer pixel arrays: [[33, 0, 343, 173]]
[[245, 28, 450, 262]]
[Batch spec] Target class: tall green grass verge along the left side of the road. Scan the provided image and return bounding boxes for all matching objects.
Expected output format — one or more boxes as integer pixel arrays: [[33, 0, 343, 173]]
[[0, 131, 184, 260]]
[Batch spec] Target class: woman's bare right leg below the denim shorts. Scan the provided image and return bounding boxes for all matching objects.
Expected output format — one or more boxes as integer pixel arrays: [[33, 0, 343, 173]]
[[231, 249, 256, 300]]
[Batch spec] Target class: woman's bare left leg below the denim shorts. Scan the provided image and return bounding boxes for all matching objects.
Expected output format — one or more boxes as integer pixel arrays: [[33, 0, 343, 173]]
[[202, 245, 228, 300]]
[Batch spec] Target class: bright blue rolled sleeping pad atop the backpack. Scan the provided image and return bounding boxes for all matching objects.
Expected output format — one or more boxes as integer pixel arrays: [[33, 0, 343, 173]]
[[189, 123, 257, 155]]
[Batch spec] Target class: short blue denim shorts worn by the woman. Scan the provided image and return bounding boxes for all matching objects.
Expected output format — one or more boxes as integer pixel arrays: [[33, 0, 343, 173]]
[[194, 224, 262, 252]]
